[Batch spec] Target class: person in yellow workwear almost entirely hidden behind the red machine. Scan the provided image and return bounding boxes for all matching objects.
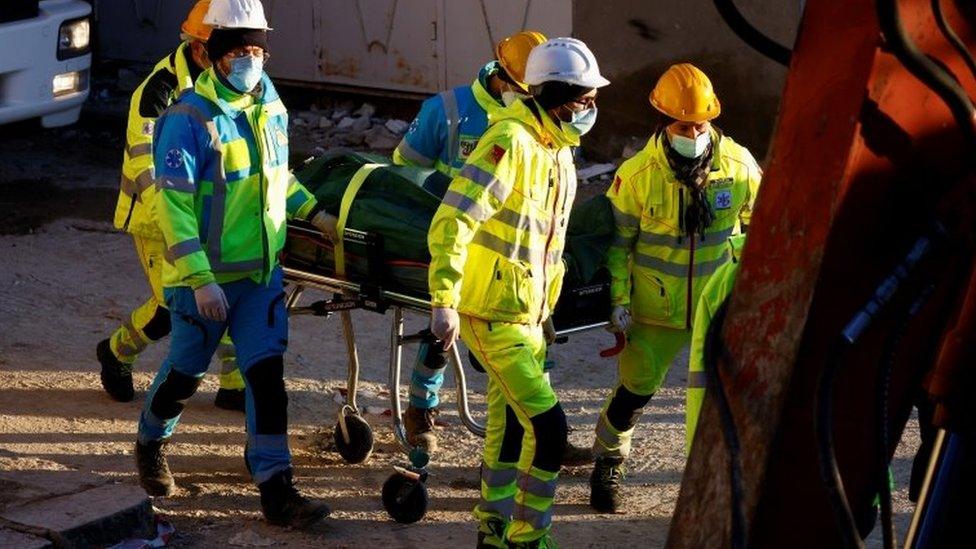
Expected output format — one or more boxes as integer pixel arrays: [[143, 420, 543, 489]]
[[685, 234, 746, 454]]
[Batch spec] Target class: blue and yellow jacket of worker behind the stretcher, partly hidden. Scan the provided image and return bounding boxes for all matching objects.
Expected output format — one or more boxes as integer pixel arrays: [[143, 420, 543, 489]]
[[393, 61, 505, 177]]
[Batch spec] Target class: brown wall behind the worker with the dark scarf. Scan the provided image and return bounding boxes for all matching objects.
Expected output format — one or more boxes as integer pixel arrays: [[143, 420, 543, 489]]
[[573, 0, 800, 161]]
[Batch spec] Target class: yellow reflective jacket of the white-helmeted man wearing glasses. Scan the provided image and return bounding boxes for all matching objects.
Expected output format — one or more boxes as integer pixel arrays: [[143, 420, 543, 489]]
[[428, 101, 579, 324]]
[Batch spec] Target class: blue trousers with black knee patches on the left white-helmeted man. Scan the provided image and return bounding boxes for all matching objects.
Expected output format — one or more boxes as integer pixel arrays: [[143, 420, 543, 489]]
[[138, 268, 291, 484]]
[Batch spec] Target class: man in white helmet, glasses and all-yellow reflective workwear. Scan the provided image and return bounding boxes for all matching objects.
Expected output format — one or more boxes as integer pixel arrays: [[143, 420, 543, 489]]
[[428, 38, 609, 547]]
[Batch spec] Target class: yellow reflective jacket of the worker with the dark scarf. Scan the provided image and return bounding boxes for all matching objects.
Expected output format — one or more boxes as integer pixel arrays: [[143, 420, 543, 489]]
[[607, 129, 762, 329]]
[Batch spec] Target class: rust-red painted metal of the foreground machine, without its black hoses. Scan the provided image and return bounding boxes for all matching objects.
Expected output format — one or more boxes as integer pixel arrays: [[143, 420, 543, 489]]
[[668, 0, 976, 547]]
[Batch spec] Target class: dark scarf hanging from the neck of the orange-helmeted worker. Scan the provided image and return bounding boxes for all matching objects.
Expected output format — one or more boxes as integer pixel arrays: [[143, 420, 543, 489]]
[[660, 130, 715, 242]]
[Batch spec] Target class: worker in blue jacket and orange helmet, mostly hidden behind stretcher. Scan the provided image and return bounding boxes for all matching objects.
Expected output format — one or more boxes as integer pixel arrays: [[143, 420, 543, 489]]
[[393, 31, 546, 454]]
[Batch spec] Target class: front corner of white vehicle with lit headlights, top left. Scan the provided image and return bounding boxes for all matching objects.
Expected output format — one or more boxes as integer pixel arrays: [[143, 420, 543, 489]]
[[0, 0, 91, 128]]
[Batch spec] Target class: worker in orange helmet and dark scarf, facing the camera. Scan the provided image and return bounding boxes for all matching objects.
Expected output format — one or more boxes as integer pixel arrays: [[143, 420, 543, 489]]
[[590, 63, 761, 512]]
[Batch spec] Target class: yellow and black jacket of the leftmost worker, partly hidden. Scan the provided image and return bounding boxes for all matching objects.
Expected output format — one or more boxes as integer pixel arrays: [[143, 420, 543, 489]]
[[114, 42, 200, 240]]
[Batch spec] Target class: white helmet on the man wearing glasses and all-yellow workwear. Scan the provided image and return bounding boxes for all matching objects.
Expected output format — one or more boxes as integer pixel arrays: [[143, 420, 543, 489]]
[[525, 38, 610, 88]]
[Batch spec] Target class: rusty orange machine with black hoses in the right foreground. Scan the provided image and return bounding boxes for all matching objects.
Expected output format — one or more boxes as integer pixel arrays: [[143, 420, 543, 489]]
[[668, 0, 976, 547]]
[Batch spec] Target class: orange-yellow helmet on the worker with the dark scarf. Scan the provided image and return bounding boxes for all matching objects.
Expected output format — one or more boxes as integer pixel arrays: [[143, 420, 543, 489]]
[[649, 63, 722, 122]]
